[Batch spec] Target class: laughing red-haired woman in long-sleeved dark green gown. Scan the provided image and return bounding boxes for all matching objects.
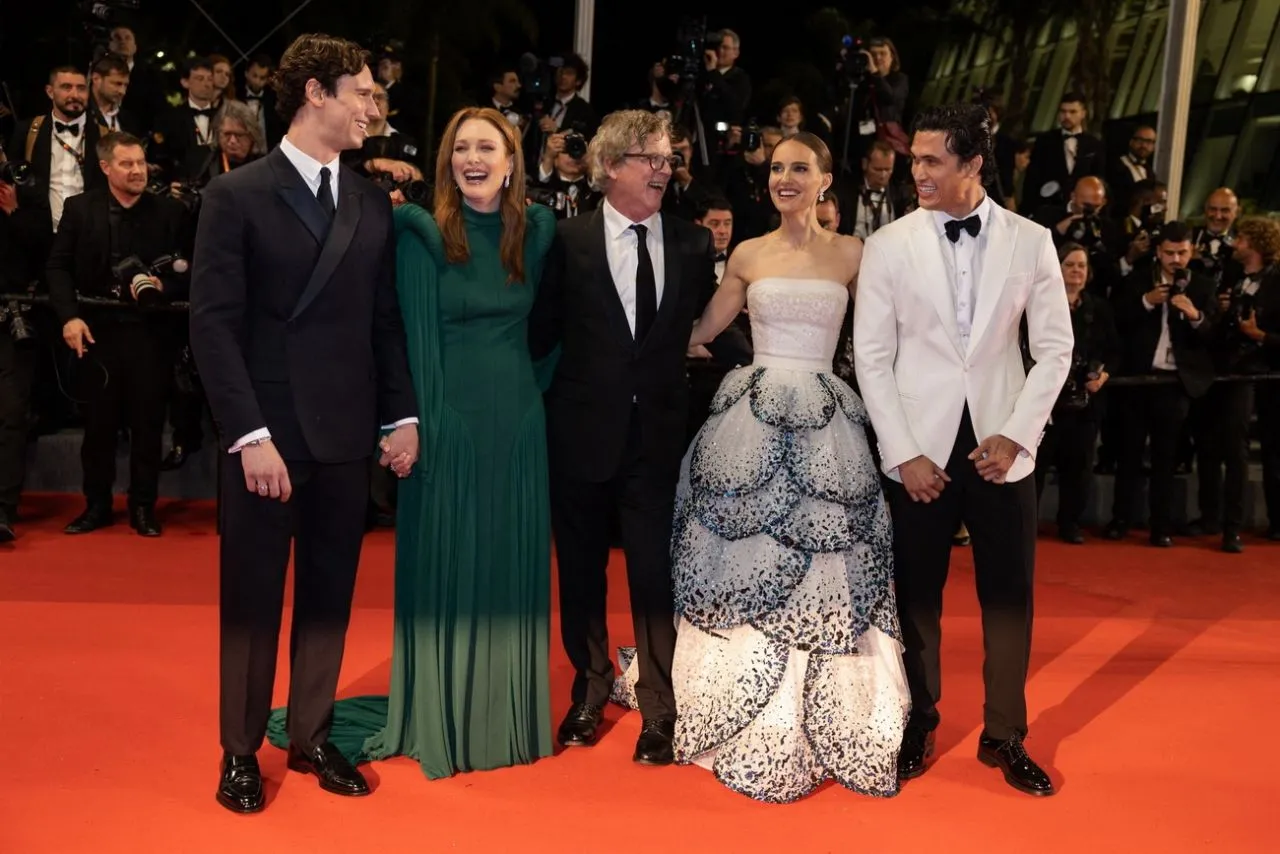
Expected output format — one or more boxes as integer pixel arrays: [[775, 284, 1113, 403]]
[[269, 108, 556, 778]]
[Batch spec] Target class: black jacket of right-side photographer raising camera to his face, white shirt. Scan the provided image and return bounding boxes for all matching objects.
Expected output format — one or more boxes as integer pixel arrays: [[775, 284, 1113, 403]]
[[1112, 262, 1217, 397]]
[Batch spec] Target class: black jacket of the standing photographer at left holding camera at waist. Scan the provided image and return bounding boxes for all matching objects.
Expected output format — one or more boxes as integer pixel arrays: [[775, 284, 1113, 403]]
[[45, 189, 191, 323]]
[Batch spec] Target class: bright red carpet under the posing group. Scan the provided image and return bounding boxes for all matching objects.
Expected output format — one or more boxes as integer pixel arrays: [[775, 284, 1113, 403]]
[[0, 497, 1280, 854]]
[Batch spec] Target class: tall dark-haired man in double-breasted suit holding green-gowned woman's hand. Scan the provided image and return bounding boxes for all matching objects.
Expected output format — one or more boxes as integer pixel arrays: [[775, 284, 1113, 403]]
[[191, 35, 417, 813]]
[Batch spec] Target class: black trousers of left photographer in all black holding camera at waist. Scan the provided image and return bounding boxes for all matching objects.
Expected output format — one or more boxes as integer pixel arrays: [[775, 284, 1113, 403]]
[[77, 316, 173, 507]]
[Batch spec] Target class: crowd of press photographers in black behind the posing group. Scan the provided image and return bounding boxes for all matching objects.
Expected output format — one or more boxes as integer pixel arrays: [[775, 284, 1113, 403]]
[[0, 21, 1280, 552]]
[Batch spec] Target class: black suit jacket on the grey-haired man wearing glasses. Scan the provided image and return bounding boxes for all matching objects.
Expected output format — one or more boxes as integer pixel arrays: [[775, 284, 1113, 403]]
[[530, 210, 716, 483]]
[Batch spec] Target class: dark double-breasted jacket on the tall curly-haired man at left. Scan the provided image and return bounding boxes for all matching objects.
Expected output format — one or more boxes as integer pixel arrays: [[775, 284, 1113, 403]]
[[191, 149, 417, 462]]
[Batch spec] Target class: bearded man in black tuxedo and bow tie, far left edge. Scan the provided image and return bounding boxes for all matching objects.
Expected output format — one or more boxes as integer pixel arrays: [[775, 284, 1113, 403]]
[[8, 65, 106, 278]]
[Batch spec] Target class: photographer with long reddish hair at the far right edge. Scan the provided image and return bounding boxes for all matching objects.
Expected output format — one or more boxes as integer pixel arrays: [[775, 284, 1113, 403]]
[[1196, 219, 1280, 545]]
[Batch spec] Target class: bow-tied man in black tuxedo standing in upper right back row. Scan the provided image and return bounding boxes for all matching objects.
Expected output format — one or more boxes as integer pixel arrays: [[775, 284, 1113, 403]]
[[1023, 92, 1106, 210]]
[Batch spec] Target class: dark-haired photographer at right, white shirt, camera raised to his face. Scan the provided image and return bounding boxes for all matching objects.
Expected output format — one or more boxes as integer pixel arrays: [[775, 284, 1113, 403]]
[[1106, 222, 1217, 547]]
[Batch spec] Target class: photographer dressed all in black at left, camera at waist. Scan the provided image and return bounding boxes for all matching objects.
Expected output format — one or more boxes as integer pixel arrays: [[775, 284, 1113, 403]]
[[46, 133, 189, 536]]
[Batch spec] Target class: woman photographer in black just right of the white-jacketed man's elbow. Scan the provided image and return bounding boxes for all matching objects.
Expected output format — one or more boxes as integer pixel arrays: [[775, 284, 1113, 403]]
[[1036, 243, 1120, 545]]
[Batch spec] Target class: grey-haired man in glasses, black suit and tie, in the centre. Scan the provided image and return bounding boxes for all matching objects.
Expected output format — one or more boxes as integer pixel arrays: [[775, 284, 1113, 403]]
[[530, 110, 716, 764]]
